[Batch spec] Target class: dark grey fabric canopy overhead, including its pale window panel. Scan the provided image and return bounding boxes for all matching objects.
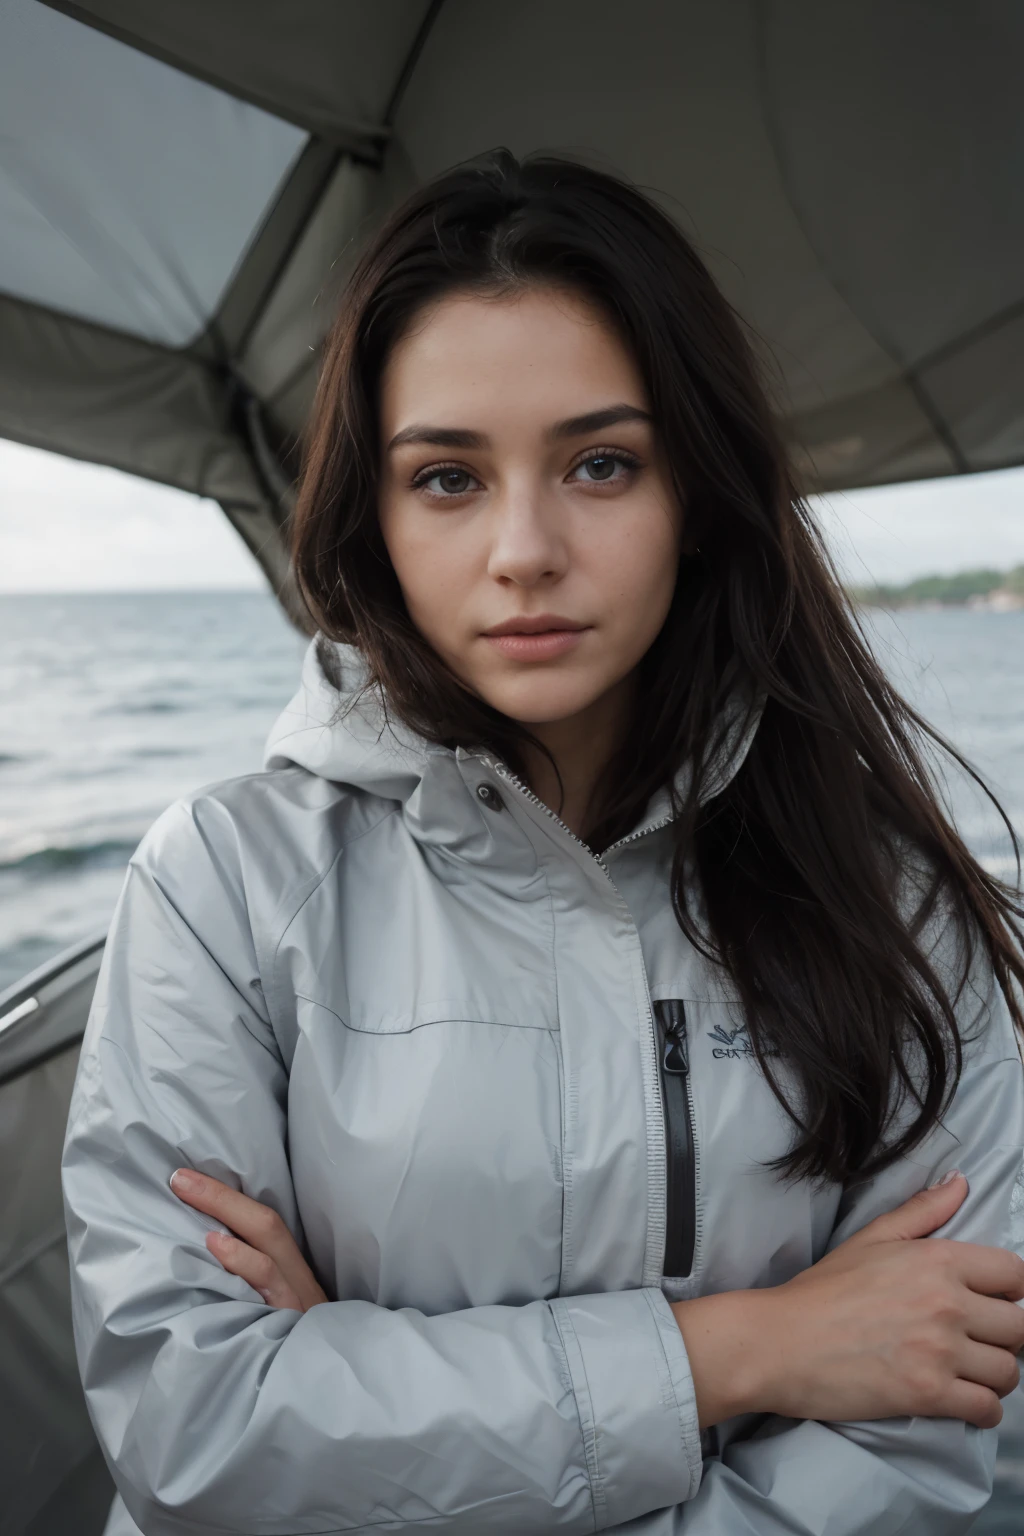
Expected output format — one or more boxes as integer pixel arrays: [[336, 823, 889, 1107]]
[[0, 0, 1024, 623]]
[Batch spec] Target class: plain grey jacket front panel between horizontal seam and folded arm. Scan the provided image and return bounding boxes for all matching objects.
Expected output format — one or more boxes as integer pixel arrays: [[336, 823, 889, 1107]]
[[289, 997, 562, 1312]]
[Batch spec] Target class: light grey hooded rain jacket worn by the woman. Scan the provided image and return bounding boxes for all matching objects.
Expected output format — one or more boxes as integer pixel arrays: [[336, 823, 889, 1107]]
[[64, 638, 1024, 1536]]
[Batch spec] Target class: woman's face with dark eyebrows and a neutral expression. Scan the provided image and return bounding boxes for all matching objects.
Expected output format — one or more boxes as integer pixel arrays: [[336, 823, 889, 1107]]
[[381, 289, 682, 725]]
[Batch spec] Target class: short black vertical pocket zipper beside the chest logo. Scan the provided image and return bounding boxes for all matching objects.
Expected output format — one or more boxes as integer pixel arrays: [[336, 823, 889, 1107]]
[[654, 997, 697, 1276]]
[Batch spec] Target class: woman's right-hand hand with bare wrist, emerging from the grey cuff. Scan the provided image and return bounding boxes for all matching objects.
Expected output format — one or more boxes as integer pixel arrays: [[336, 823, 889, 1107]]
[[672, 1175, 1024, 1428]]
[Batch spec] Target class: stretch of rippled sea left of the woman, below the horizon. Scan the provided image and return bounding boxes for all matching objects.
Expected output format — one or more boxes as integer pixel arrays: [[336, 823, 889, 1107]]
[[0, 593, 304, 991]]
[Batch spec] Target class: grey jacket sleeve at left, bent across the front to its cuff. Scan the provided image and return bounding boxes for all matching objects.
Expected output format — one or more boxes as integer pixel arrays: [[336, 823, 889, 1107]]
[[63, 802, 700, 1536]]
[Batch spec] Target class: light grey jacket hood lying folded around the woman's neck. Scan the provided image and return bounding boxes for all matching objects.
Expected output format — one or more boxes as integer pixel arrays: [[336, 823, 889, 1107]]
[[264, 636, 763, 825]]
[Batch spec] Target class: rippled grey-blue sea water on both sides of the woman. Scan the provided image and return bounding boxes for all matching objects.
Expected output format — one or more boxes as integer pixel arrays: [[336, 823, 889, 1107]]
[[0, 593, 1024, 1536]]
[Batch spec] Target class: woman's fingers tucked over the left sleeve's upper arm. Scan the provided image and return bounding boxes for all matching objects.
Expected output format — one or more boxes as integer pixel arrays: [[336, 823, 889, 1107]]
[[170, 1167, 327, 1312]]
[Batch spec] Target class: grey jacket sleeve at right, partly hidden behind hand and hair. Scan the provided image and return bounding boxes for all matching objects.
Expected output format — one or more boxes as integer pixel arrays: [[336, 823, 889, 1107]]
[[682, 933, 1024, 1536]]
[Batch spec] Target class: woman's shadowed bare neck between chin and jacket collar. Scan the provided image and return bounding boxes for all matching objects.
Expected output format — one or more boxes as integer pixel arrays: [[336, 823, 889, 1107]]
[[522, 677, 634, 842]]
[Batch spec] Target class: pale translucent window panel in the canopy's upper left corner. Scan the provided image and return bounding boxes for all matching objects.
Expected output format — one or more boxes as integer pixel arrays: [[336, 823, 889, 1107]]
[[0, 0, 307, 347]]
